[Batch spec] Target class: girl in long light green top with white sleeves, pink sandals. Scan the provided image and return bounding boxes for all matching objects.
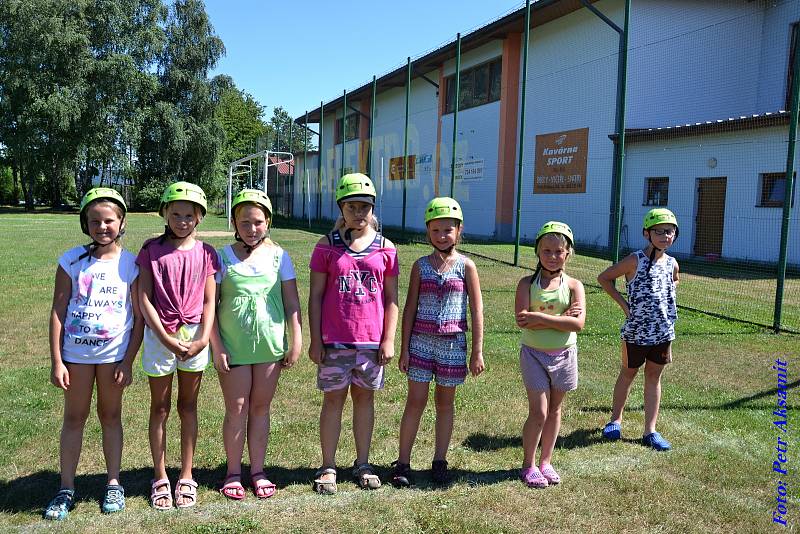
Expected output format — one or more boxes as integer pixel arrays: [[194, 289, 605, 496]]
[[211, 189, 303, 500]]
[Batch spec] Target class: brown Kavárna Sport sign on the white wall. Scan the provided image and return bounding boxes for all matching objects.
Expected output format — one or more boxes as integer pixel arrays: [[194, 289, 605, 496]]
[[533, 128, 589, 193]]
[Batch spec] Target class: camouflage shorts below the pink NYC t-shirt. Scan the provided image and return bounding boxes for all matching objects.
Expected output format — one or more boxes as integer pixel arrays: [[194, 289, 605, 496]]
[[317, 349, 383, 392]]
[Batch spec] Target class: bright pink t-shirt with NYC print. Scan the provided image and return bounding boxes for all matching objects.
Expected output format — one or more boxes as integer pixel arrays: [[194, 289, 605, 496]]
[[309, 235, 400, 349]]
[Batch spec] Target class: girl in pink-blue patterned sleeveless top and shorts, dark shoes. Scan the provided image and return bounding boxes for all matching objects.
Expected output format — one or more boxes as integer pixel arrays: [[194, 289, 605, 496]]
[[392, 197, 484, 487]]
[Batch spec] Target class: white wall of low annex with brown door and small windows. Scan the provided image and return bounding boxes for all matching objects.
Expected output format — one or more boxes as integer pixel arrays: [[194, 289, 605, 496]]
[[621, 126, 800, 265]]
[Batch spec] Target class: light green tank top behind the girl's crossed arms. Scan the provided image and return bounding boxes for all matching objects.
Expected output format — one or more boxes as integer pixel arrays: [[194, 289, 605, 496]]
[[522, 273, 578, 350]]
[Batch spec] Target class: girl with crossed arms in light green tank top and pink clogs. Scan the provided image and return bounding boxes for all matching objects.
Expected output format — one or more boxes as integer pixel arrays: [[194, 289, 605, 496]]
[[514, 221, 586, 488]]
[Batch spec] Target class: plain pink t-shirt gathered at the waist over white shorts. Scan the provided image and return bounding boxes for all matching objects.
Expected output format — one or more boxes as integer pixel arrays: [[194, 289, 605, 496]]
[[136, 238, 219, 334]]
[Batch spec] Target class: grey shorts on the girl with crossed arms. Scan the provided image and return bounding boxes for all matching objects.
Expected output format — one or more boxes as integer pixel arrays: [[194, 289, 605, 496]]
[[519, 345, 578, 391]]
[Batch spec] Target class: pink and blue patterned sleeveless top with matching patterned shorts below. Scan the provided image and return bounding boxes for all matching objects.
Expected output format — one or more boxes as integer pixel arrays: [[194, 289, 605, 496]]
[[412, 254, 467, 335]]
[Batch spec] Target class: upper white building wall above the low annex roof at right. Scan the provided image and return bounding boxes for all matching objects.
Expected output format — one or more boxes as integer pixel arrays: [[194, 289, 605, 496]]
[[626, 0, 780, 128]]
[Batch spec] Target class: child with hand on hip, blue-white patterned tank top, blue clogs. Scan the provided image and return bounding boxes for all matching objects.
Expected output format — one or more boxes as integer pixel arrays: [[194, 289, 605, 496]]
[[597, 208, 678, 451]]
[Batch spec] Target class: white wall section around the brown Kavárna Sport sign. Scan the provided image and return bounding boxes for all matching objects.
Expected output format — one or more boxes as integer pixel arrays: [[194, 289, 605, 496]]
[[520, 0, 623, 246]]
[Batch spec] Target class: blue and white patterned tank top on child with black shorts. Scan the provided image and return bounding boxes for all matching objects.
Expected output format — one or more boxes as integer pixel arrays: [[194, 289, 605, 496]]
[[620, 250, 678, 345]]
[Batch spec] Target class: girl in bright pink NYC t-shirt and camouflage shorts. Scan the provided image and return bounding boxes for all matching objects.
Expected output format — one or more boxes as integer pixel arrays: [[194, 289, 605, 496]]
[[308, 173, 399, 494]]
